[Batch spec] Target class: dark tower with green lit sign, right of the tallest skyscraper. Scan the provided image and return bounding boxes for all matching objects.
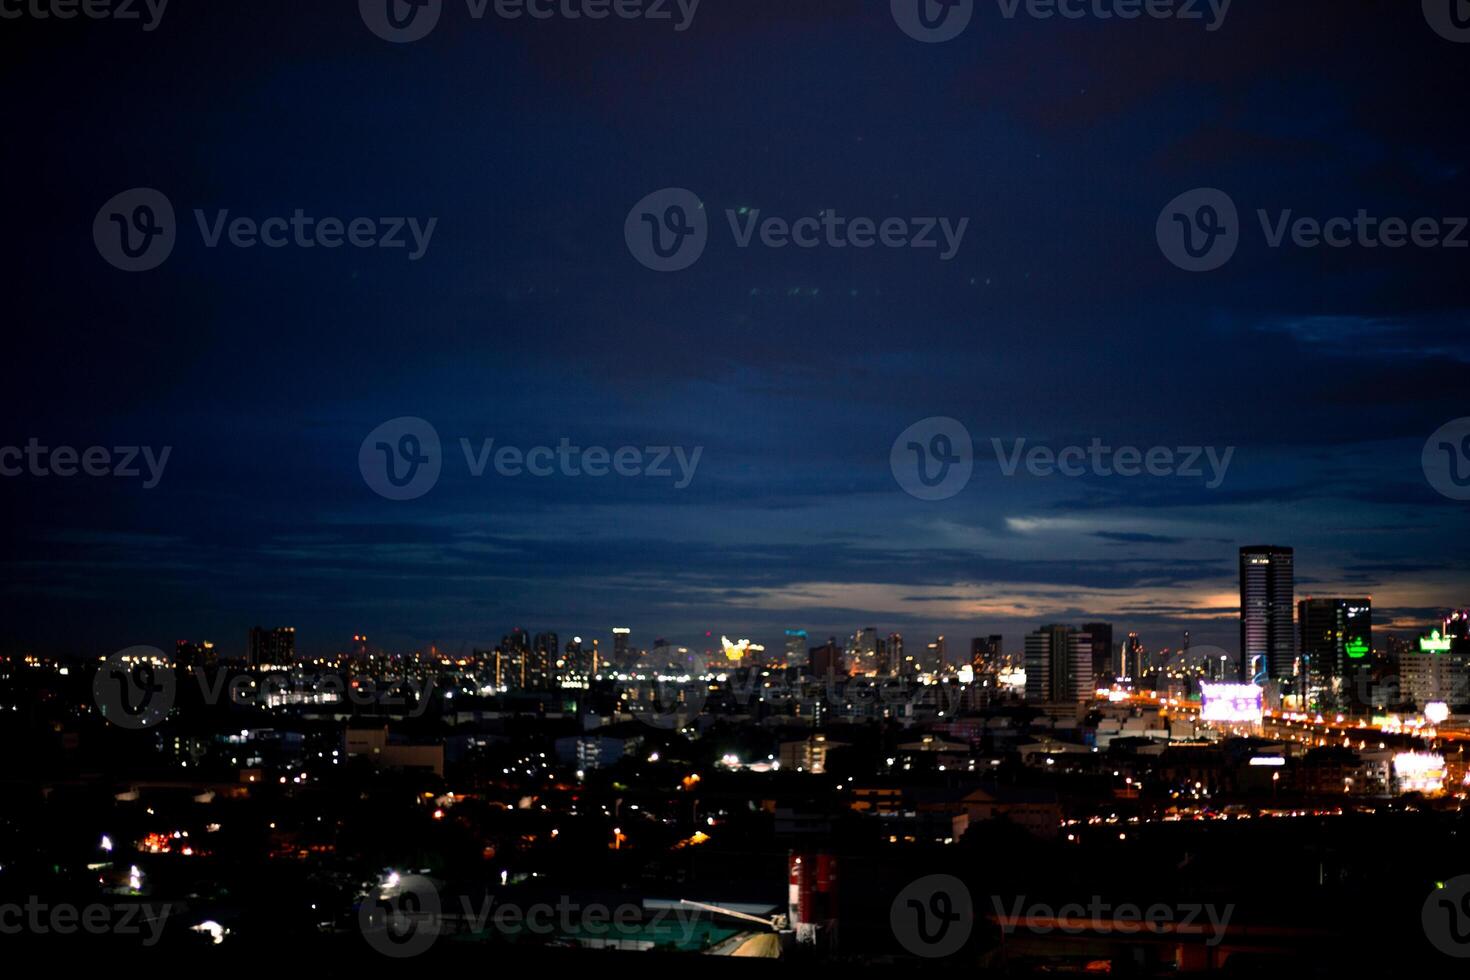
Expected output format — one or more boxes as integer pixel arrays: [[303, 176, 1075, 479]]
[[1297, 597, 1373, 714]]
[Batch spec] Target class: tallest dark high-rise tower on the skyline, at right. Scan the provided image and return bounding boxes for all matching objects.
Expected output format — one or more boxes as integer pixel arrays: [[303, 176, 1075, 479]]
[[1241, 545, 1297, 693]]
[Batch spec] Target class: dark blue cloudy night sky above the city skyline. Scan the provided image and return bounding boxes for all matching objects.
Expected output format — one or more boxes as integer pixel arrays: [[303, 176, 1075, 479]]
[[0, 0, 1470, 664]]
